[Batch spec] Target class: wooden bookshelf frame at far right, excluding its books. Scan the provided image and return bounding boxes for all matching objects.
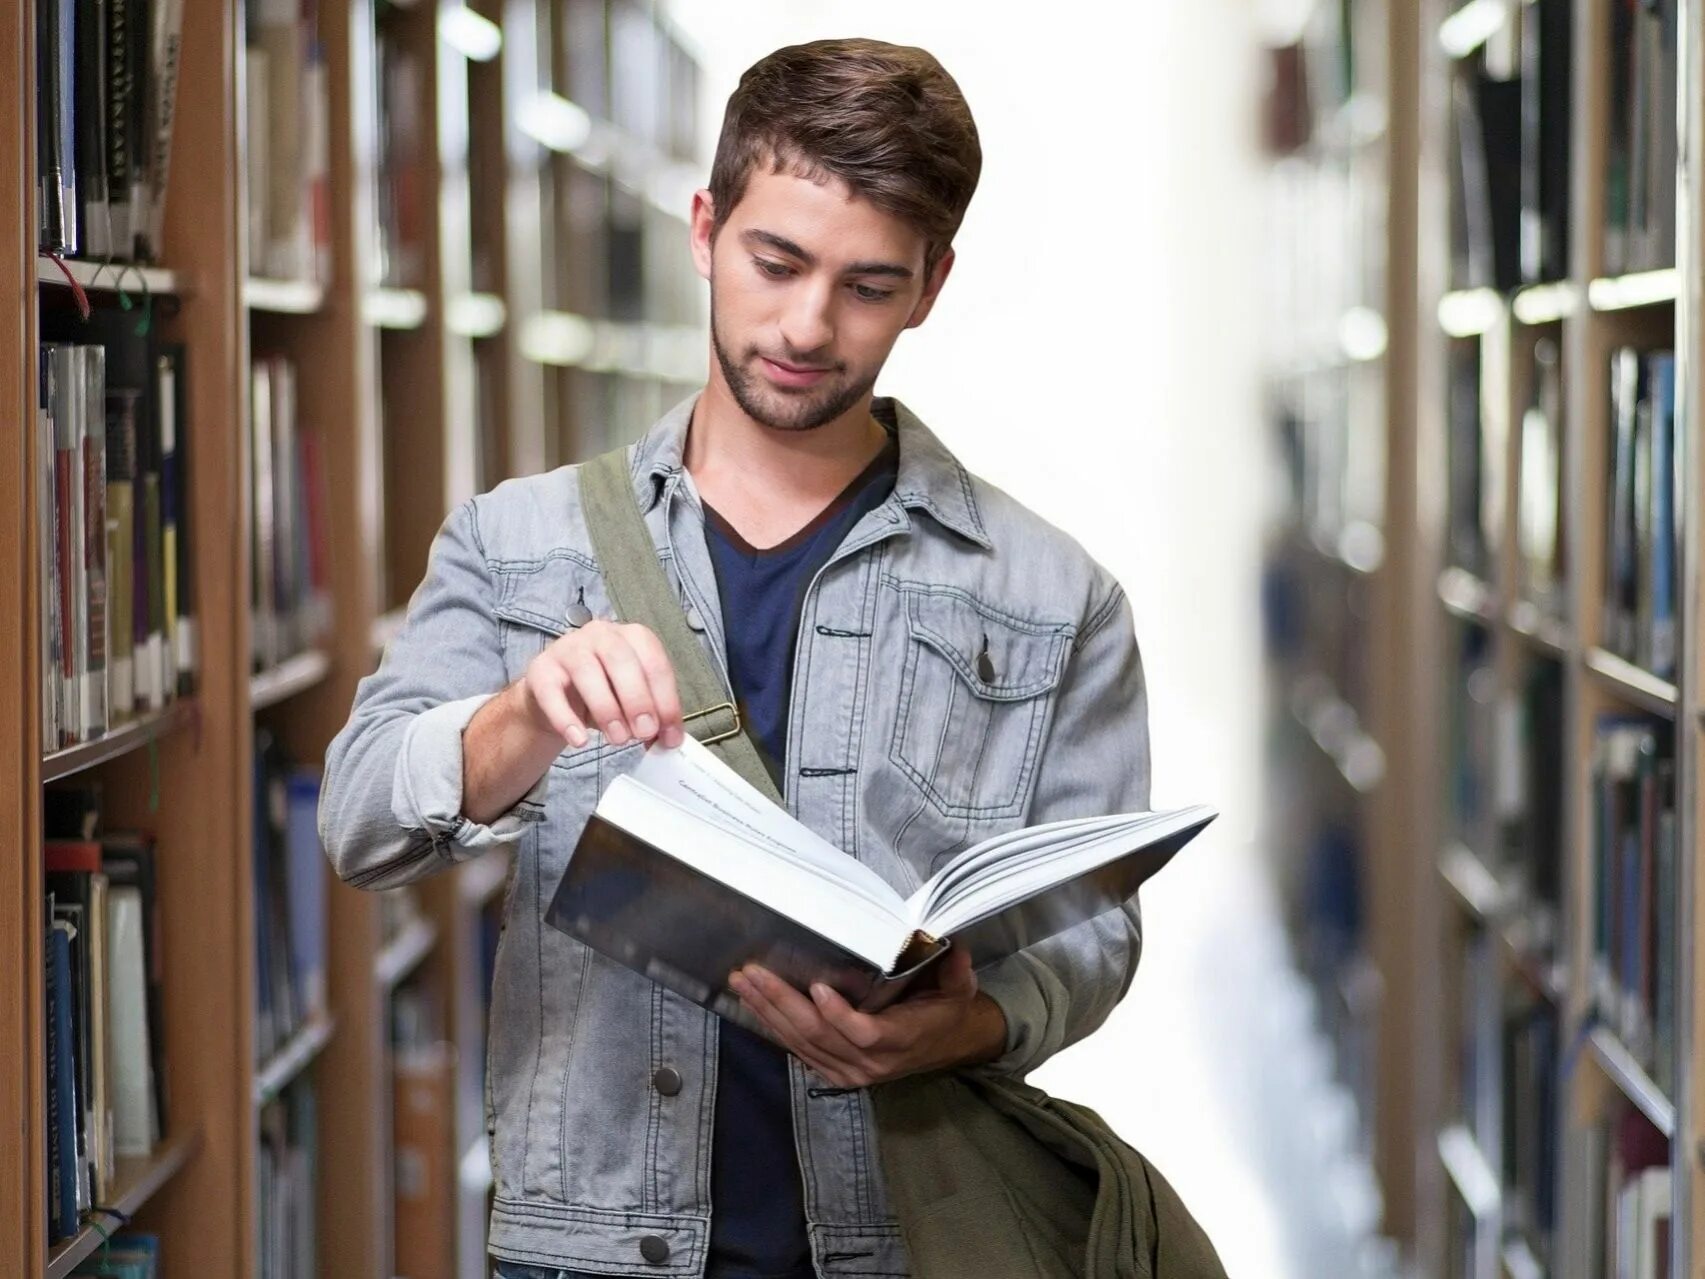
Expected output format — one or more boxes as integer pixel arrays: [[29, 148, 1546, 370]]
[[1386, 0, 1705, 1279]]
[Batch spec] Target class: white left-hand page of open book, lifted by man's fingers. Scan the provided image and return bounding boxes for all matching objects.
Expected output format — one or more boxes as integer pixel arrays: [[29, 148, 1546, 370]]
[[620, 737, 905, 919]]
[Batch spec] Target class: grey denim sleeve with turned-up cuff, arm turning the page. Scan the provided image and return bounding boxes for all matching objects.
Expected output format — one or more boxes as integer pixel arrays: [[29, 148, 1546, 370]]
[[319, 501, 549, 888]]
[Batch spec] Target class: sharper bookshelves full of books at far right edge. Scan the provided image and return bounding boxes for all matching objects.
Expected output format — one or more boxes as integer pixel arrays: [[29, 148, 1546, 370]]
[[1417, 0, 1700, 1279]]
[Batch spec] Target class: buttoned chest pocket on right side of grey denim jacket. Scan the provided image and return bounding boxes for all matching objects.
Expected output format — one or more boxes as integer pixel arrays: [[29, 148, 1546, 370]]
[[888, 585, 1072, 819]]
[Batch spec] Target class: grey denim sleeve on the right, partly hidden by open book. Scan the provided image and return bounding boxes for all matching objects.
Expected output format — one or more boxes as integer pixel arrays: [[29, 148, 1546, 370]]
[[977, 583, 1149, 1076]]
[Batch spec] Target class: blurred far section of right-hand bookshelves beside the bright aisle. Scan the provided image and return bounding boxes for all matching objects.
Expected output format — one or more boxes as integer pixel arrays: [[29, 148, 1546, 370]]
[[1263, 0, 1425, 1240]]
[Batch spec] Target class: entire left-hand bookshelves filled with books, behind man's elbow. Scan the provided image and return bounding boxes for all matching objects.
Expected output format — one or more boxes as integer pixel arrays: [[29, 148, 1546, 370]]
[[0, 0, 702, 1279]]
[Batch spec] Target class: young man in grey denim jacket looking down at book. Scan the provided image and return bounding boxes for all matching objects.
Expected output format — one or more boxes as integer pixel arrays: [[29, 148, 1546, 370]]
[[321, 41, 1149, 1279]]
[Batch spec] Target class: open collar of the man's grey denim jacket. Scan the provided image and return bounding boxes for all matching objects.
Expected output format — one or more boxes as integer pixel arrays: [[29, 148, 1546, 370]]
[[631, 392, 994, 551]]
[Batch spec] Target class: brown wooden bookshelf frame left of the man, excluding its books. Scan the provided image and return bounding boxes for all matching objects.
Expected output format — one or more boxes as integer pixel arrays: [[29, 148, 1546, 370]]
[[0, 0, 706, 1279]]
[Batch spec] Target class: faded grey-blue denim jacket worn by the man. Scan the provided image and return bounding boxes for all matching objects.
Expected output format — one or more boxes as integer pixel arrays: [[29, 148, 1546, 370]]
[[321, 399, 1149, 1279]]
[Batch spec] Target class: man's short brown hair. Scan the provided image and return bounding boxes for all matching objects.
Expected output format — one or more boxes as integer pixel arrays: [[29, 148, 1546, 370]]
[[711, 39, 982, 275]]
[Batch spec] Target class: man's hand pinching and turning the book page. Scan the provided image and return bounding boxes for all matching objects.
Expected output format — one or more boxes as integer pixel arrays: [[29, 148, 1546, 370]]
[[520, 619, 685, 749]]
